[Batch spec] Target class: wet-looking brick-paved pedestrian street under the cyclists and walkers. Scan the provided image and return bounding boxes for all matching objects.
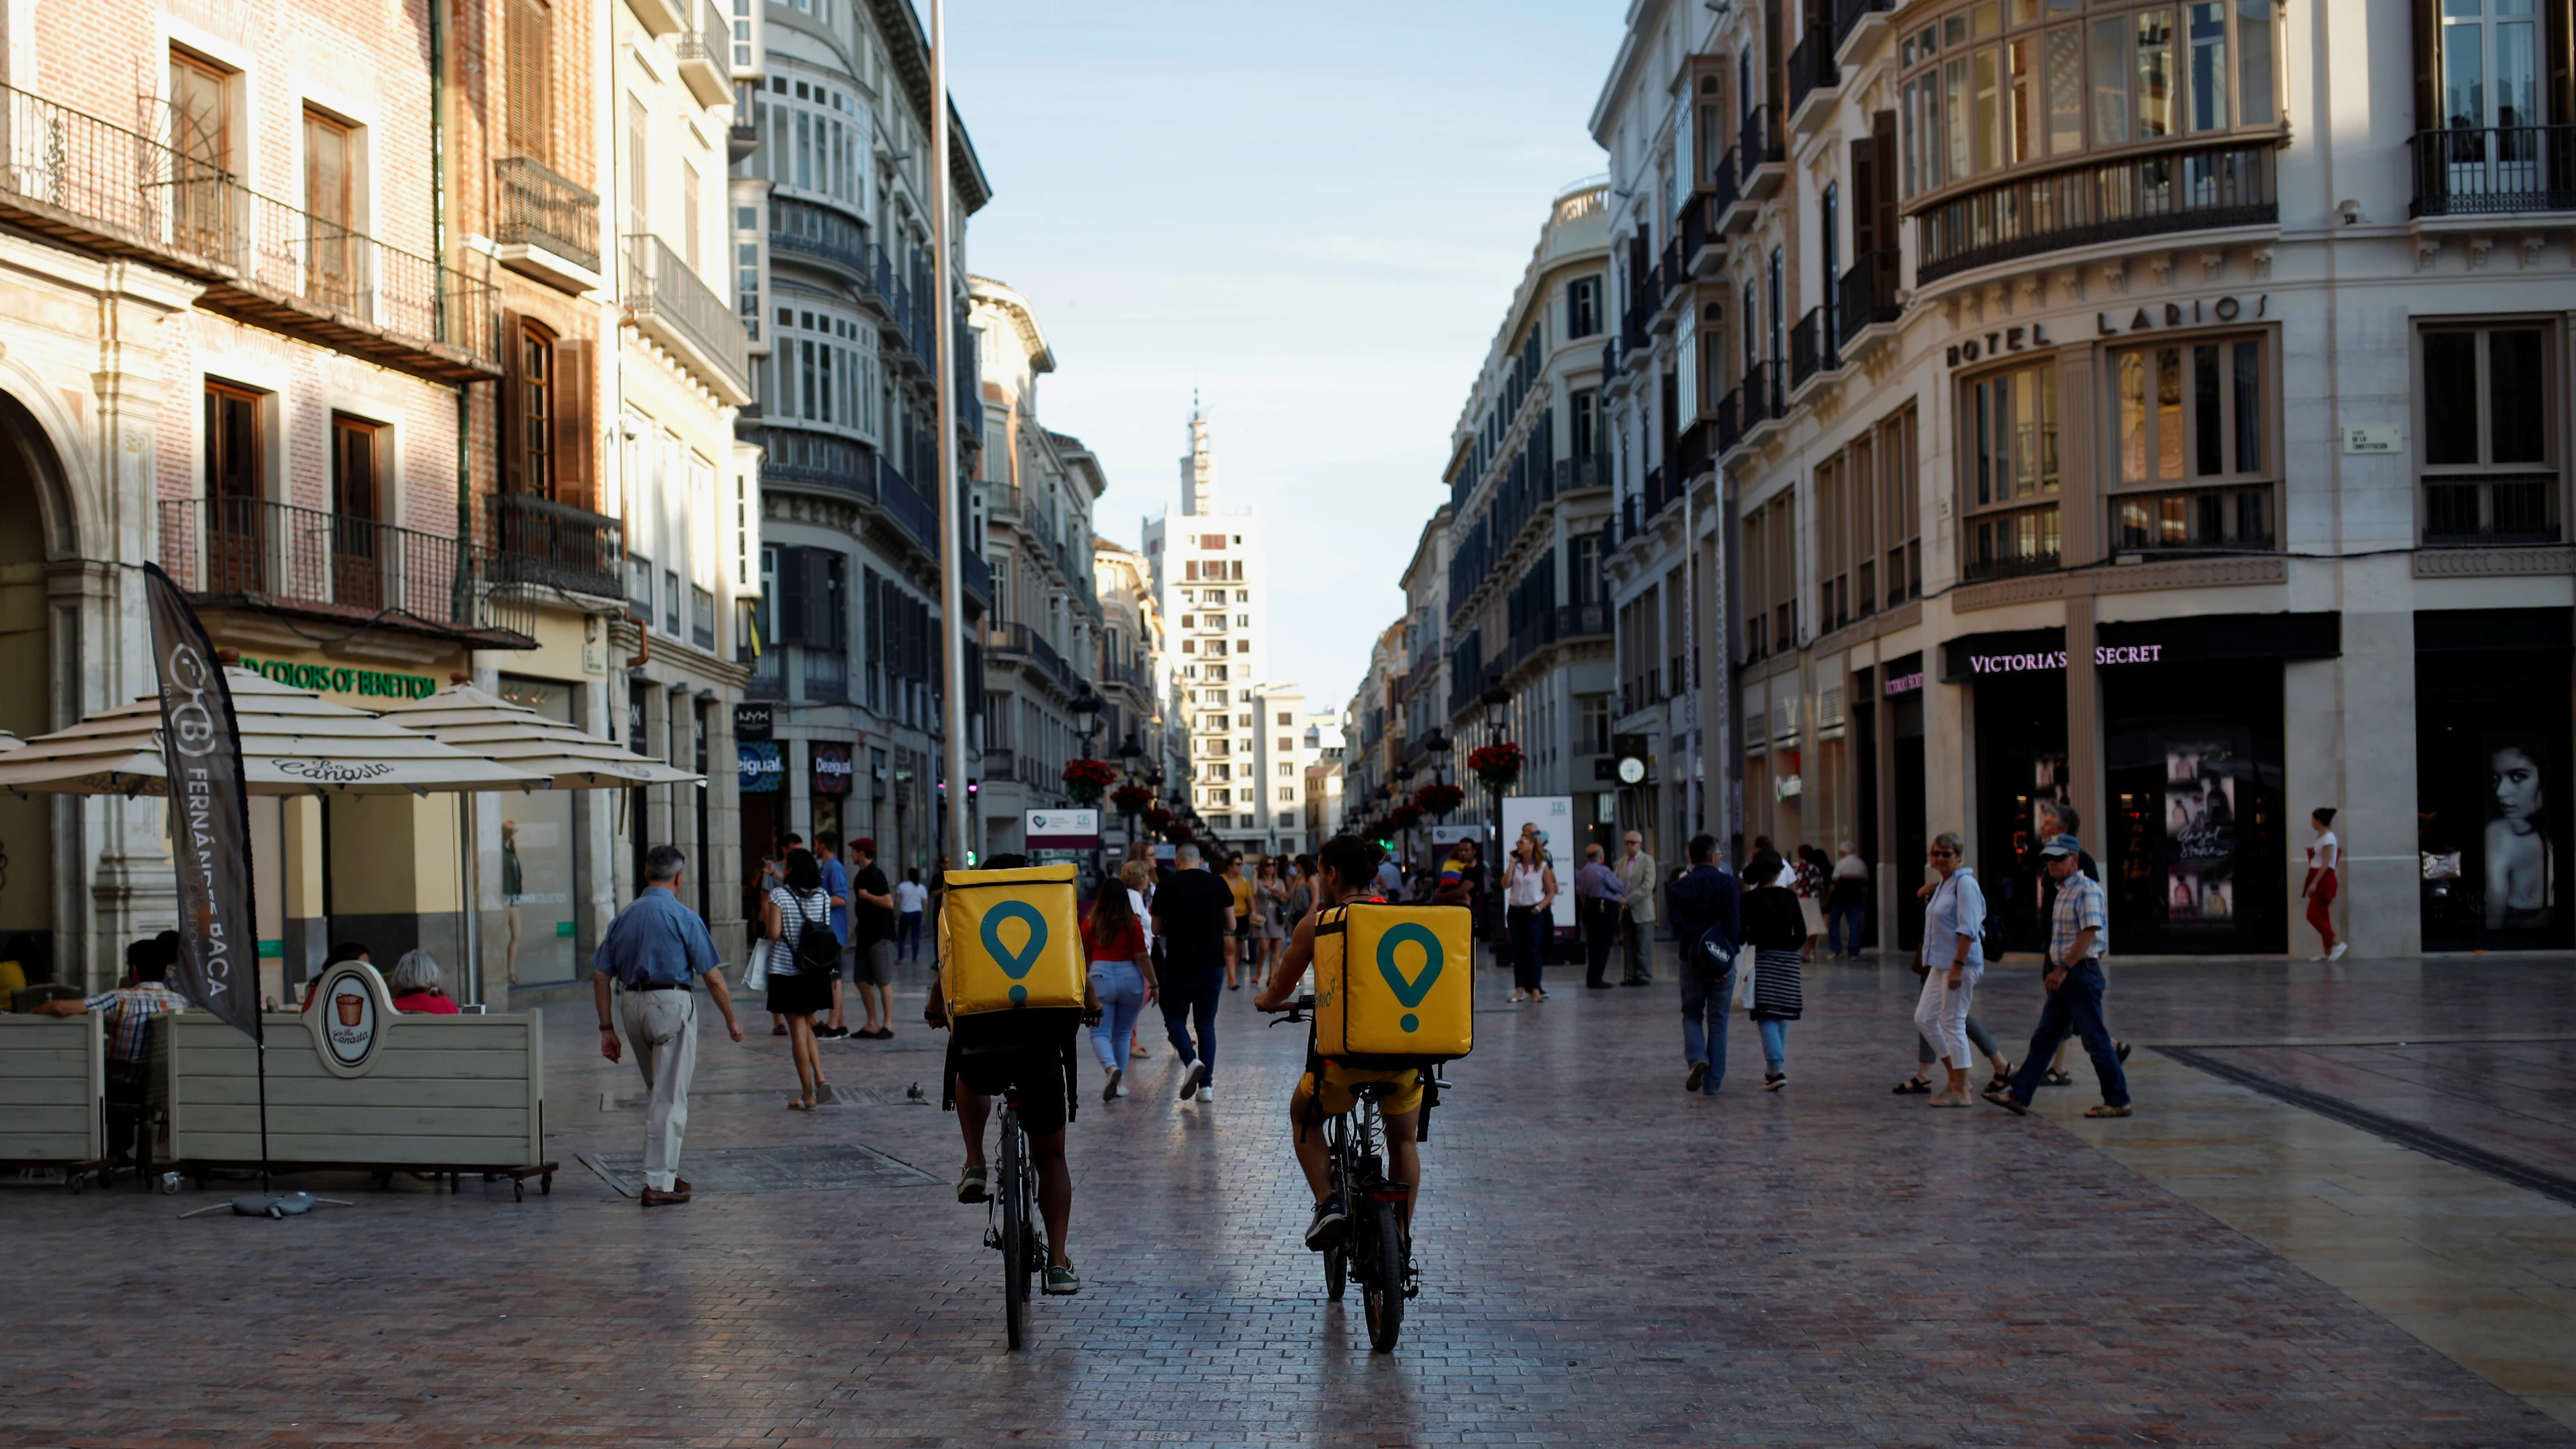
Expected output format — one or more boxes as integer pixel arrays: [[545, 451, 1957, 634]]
[[0, 963, 2576, 1446]]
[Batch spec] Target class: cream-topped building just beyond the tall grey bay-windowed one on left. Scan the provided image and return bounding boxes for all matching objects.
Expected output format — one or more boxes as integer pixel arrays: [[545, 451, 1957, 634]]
[[971, 278, 1092, 852]]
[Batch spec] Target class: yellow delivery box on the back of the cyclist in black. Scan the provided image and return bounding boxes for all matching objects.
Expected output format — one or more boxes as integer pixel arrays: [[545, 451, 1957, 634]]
[[940, 864, 1085, 1016]]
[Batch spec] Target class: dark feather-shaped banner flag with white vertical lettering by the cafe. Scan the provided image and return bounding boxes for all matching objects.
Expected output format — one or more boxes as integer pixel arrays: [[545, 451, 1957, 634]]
[[144, 563, 260, 1040]]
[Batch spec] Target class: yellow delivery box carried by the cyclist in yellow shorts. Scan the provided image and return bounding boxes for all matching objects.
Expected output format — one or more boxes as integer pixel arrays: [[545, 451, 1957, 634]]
[[1314, 901, 1476, 1068]]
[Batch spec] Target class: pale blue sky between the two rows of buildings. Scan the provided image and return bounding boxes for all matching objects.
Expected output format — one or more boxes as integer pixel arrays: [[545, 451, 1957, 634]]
[[947, 0, 1626, 710]]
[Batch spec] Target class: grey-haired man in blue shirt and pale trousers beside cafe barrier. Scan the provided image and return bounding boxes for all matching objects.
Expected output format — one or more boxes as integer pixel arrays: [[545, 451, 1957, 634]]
[[590, 844, 742, 1207]]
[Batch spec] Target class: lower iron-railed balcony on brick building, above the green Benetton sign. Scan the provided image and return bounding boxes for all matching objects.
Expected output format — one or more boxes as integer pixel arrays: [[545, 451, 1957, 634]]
[[160, 499, 536, 649]]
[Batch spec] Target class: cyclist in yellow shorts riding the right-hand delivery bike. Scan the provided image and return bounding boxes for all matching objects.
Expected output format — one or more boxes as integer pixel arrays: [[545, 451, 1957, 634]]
[[1252, 836, 1422, 1253]]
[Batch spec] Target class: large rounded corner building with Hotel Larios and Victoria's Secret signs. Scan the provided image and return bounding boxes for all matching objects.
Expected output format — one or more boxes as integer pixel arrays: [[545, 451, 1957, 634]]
[[1594, 0, 2576, 955]]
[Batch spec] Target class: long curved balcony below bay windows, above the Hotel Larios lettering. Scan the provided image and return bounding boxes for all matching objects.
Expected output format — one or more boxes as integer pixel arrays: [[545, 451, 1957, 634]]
[[1914, 142, 2280, 286]]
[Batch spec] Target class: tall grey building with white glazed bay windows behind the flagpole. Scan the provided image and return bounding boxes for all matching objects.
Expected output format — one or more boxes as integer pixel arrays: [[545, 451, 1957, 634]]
[[724, 0, 992, 875]]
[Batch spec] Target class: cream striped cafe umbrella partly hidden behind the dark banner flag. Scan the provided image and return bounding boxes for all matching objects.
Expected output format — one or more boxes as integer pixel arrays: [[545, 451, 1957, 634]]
[[0, 667, 554, 795]]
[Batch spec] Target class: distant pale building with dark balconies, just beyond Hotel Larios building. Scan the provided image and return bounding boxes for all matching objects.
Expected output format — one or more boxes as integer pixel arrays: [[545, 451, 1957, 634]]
[[1443, 180, 1615, 859]]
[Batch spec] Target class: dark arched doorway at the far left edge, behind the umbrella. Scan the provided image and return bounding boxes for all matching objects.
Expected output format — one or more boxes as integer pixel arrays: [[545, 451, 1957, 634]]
[[0, 394, 80, 988]]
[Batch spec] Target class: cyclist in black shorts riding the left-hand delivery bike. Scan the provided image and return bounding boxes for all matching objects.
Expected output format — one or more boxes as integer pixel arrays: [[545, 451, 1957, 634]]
[[922, 854, 1100, 1295]]
